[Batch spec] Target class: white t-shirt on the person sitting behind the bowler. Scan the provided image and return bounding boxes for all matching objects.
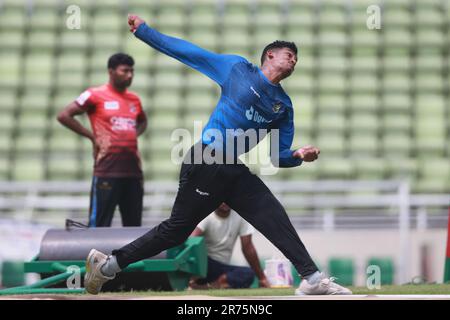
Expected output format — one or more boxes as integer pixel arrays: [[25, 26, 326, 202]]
[[197, 211, 255, 264]]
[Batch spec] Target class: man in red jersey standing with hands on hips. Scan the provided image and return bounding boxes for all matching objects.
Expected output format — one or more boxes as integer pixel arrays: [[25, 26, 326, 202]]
[[58, 53, 147, 227]]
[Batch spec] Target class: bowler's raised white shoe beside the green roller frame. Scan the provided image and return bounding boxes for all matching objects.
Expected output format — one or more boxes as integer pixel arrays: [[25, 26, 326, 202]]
[[84, 249, 115, 294]]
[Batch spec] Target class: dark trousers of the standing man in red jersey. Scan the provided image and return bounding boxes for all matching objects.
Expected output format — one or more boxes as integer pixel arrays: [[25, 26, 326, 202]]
[[89, 176, 144, 227]]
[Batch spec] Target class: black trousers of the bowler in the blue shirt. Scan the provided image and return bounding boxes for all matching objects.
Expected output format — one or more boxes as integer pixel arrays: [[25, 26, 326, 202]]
[[113, 147, 318, 277]]
